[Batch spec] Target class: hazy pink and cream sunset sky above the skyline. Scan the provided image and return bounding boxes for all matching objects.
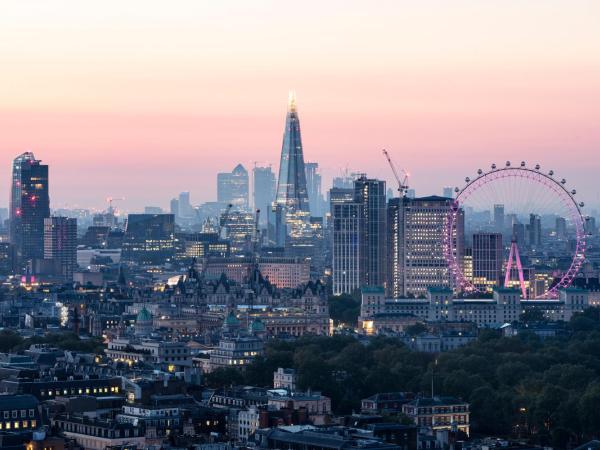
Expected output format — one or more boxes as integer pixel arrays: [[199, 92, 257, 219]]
[[0, 0, 600, 209]]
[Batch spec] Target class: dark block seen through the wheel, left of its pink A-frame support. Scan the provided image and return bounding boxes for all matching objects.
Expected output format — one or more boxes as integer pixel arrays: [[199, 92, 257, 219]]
[[472, 233, 504, 291]]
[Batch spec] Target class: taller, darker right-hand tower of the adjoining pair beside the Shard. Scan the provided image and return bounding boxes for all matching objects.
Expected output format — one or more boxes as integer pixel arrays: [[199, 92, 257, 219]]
[[354, 175, 387, 286]]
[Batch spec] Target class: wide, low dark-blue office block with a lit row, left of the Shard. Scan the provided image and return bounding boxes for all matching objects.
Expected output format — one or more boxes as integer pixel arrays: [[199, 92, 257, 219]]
[[123, 214, 175, 265]]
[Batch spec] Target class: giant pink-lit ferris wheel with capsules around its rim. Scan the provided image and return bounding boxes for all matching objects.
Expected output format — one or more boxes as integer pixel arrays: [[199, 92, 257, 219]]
[[444, 161, 586, 299]]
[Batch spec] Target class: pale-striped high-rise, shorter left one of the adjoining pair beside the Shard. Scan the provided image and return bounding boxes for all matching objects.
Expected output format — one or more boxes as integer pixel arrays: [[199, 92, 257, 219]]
[[331, 201, 365, 295]]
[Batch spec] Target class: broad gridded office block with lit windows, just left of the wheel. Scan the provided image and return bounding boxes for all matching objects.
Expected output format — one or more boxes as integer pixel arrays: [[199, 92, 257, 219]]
[[387, 196, 464, 298]]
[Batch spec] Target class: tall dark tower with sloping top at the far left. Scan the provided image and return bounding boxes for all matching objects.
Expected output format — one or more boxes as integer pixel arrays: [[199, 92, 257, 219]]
[[9, 152, 50, 269]]
